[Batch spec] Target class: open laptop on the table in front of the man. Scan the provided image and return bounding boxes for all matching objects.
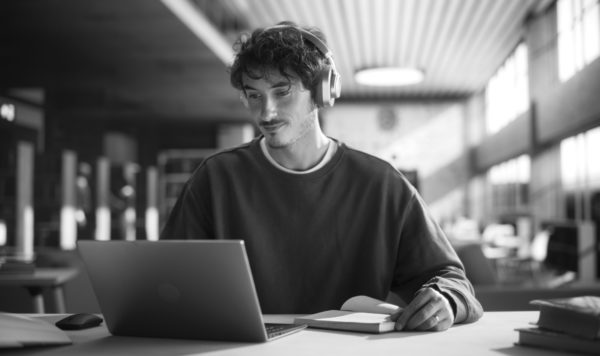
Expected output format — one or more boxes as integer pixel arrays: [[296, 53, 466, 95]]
[[77, 240, 306, 342]]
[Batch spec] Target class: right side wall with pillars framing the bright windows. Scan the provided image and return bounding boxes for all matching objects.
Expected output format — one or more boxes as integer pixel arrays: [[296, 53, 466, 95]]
[[458, 2, 600, 229]]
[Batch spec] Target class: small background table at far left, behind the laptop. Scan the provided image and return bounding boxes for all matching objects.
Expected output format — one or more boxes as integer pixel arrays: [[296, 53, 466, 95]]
[[0, 268, 79, 313]]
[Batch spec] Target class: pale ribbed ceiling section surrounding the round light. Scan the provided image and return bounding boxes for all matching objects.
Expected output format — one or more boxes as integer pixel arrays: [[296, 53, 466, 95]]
[[225, 0, 539, 99]]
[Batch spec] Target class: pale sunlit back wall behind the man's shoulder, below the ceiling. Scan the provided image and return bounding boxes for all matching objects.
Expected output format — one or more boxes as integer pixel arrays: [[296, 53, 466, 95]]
[[323, 101, 470, 222]]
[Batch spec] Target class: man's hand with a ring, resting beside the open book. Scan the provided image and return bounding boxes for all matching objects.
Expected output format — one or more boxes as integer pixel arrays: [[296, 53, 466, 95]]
[[391, 288, 454, 331]]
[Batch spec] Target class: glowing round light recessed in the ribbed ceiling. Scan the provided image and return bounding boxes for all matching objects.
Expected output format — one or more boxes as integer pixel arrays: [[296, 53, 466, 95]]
[[354, 67, 425, 86]]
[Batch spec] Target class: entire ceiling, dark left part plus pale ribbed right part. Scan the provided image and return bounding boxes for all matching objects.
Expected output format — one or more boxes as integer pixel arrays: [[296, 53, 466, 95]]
[[0, 0, 552, 121]]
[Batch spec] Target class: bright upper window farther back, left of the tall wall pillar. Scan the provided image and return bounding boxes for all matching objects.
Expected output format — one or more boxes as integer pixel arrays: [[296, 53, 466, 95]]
[[485, 43, 529, 135]]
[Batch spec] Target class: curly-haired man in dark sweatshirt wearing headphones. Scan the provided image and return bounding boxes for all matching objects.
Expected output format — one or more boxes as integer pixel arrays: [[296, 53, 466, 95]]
[[162, 23, 483, 330]]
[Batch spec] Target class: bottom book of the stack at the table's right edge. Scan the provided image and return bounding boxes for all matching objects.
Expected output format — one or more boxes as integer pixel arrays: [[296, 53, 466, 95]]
[[517, 328, 600, 355]]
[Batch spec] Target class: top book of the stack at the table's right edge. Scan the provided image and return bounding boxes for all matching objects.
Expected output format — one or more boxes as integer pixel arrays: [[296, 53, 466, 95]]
[[531, 296, 600, 339]]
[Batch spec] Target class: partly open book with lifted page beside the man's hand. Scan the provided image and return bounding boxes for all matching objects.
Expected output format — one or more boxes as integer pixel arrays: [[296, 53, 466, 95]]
[[294, 295, 401, 334]]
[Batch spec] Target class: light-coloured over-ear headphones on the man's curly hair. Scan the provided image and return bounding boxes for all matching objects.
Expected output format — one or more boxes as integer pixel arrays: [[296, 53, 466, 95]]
[[263, 25, 342, 108]]
